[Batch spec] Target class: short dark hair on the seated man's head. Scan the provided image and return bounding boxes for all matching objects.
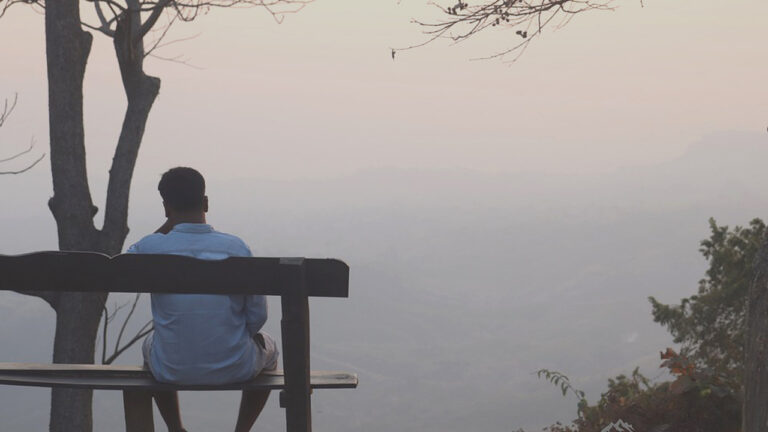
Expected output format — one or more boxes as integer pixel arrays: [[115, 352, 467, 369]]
[[157, 167, 205, 211]]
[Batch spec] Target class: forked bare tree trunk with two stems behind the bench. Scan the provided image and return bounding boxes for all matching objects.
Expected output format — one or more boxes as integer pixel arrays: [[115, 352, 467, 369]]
[[39, 0, 160, 432]]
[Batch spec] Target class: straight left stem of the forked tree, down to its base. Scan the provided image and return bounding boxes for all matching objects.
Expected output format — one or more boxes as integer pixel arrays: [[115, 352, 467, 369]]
[[45, 0, 106, 432]]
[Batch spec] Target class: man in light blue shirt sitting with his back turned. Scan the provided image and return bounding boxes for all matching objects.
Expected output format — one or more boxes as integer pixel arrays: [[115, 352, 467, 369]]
[[128, 167, 278, 432]]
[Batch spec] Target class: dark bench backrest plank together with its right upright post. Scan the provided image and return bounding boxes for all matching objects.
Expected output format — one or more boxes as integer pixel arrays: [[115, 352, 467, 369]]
[[0, 251, 349, 432]]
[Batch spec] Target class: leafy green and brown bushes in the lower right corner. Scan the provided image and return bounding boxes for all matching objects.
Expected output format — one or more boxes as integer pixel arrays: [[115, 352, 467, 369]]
[[519, 219, 766, 432]]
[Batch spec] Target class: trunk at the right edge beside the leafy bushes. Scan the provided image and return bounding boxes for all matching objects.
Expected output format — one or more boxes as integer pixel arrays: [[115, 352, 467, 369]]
[[741, 238, 768, 432]]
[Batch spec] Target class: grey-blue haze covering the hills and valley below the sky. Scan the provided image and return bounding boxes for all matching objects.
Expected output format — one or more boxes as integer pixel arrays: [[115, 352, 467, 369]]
[[0, 134, 768, 432]]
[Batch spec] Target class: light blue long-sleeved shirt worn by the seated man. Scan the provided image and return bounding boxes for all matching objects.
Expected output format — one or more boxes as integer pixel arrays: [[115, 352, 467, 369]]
[[127, 223, 267, 384]]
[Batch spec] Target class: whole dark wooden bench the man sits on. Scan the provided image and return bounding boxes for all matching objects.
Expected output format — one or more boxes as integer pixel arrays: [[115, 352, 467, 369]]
[[0, 251, 357, 432]]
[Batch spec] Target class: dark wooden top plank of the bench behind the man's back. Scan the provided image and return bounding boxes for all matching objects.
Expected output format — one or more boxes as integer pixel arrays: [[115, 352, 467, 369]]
[[0, 251, 349, 297]]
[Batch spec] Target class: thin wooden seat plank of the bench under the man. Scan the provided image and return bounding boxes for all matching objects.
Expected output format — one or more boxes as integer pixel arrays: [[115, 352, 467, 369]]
[[0, 363, 357, 391]]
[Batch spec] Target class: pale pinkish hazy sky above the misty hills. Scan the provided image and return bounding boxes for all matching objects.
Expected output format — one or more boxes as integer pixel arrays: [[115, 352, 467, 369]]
[[0, 0, 768, 185]]
